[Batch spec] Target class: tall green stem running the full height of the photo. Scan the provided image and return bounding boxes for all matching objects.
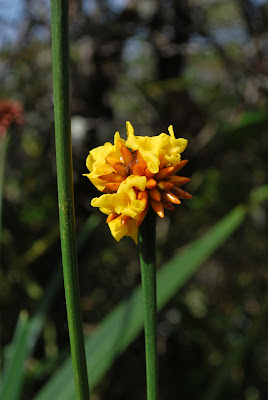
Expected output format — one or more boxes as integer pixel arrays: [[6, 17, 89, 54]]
[[51, 0, 89, 400]]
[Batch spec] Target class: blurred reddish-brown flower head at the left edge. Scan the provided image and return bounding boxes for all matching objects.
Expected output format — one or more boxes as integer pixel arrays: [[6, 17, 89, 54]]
[[0, 100, 25, 137]]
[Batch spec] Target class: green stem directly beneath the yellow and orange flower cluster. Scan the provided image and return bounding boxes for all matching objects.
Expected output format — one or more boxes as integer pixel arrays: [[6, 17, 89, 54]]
[[139, 209, 158, 400]]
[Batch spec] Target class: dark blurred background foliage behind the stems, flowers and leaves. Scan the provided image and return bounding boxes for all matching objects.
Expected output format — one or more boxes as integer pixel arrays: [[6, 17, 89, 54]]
[[0, 0, 268, 400]]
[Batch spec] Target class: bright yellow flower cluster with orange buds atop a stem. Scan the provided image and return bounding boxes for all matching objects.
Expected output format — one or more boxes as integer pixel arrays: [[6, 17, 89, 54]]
[[85, 122, 192, 243]]
